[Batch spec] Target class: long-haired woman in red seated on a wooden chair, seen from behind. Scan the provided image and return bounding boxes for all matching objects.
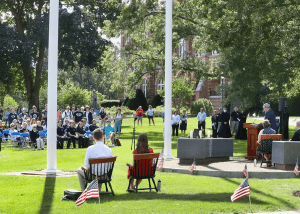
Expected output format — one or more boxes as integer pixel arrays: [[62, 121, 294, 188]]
[[127, 134, 153, 192]]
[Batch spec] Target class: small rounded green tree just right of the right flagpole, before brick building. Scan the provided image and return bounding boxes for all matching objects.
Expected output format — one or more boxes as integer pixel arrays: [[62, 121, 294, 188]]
[[159, 75, 195, 113]]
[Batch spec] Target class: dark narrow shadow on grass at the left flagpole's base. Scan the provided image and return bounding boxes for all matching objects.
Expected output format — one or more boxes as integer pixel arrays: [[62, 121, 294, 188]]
[[38, 177, 56, 214]]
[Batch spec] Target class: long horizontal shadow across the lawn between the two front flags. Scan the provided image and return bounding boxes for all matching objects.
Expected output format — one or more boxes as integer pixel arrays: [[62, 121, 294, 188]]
[[86, 192, 268, 204]]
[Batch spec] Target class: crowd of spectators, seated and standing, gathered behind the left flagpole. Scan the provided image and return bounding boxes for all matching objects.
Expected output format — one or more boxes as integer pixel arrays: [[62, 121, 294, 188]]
[[0, 104, 123, 150]]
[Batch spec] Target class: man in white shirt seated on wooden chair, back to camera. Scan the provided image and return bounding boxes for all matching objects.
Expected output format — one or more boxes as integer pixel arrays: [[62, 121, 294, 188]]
[[77, 128, 113, 191]]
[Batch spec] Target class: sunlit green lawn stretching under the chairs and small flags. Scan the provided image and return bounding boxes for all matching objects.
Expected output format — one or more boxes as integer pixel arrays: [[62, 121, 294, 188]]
[[0, 118, 300, 213]]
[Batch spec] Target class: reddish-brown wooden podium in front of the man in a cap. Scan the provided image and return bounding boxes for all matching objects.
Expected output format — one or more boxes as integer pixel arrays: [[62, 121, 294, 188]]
[[243, 123, 260, 160]]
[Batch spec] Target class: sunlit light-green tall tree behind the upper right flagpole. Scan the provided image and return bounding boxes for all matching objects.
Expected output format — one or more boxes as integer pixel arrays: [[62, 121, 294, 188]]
[[102, 0, 213, 97]]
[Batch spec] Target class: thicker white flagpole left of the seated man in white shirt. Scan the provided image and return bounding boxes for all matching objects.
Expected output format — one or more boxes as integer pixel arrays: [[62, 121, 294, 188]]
[[47, 0, 59, 173]]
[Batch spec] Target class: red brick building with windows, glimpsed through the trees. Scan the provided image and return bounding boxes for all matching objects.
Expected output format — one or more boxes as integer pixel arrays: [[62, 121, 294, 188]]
[[121, 36, 227, 110]]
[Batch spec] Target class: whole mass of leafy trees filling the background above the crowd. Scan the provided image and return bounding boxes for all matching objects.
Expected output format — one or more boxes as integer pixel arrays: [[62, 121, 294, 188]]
[[0, 0, 300, 113]]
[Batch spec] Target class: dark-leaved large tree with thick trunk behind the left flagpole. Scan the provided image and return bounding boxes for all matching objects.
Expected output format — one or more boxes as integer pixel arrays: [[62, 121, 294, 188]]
[[0, 0, 119, 112]]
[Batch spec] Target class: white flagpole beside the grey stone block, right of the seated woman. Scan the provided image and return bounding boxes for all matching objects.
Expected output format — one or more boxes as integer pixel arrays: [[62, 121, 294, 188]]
[[164, 0, 173, 159]]
